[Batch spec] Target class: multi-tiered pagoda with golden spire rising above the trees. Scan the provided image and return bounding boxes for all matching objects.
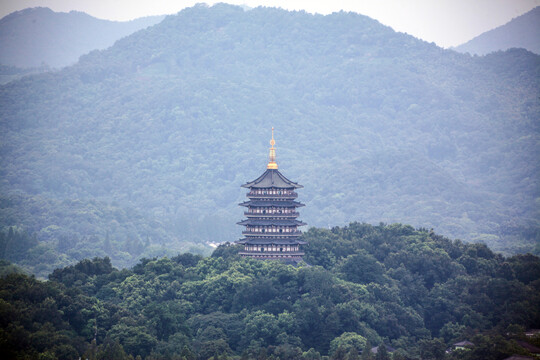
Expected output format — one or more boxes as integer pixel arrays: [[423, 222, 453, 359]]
[[236, 128, 306, 262]]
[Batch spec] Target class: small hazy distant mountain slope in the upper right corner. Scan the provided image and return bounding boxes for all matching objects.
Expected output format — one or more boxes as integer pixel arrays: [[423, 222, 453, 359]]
[[454, 6, 540, 55]]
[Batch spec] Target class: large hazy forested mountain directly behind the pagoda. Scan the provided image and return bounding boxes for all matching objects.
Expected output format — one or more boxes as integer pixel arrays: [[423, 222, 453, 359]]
[[0, 4, 540, 276]]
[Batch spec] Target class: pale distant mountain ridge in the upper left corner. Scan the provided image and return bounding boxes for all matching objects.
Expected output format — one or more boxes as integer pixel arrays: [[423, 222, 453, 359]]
[[0, 7, 164, 68]]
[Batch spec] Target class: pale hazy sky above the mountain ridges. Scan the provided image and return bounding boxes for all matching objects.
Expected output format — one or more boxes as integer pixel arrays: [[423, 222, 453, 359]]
[[0, 0, 540, 47]]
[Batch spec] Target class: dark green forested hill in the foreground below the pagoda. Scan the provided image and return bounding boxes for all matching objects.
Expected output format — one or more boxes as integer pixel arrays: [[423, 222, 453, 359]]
[[0, 223, 540, 360]]
